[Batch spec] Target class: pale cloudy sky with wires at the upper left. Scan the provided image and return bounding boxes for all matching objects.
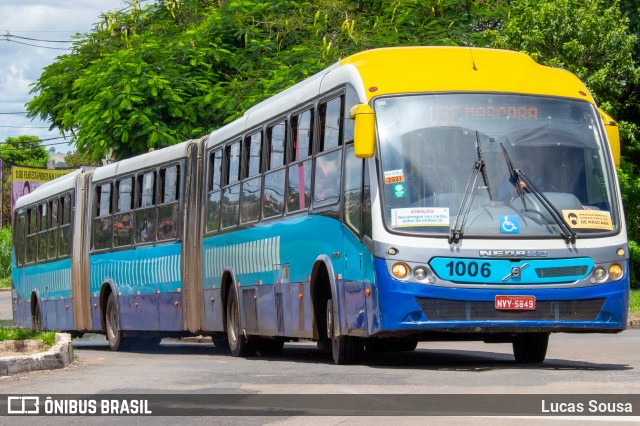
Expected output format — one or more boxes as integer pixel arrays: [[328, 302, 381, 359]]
[[0, 0, 126, 152]]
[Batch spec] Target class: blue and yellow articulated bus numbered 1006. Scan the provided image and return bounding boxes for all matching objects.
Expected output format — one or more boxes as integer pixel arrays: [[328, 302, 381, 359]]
[[12, 47, 629, 364]]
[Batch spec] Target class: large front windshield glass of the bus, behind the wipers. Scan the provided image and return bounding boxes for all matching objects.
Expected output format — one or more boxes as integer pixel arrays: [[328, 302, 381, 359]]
[[374, 94, 617, 238]]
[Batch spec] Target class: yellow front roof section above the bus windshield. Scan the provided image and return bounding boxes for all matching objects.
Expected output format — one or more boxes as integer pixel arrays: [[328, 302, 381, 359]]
[[340, 47, 594, 103]]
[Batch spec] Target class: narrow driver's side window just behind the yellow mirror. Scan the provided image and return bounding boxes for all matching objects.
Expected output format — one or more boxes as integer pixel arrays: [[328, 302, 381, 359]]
[[343, 145, 364, 236]]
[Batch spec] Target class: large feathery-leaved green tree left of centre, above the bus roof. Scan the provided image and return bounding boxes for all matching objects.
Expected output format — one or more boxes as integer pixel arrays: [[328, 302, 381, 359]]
[[27, 0, 508, 159]]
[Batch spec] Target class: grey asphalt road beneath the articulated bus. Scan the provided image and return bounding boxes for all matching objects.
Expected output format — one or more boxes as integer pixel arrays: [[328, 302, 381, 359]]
[[0, 292, 640, 425]]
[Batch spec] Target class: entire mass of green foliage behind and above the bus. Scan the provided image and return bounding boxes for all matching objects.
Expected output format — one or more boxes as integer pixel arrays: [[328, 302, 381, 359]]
[[18, 0, 640, 292]]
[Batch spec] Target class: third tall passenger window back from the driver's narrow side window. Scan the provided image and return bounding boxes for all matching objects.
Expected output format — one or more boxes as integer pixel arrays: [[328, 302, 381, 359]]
[[262, 121, 287, 218]]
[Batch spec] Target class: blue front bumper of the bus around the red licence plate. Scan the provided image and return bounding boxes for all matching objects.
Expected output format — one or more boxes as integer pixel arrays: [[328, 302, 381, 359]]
[[374, 259, 629, 332]]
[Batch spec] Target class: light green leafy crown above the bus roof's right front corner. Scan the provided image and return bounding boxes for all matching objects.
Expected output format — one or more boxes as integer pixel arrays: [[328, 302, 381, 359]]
[[488, 0, 638, 111]]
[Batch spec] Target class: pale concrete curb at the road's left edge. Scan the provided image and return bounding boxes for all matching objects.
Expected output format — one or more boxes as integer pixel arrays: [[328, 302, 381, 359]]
[[0, 333, 73, 376]]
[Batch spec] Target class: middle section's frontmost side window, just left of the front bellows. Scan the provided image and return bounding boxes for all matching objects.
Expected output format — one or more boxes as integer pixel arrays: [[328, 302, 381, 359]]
[[158, 165, 180, 240]]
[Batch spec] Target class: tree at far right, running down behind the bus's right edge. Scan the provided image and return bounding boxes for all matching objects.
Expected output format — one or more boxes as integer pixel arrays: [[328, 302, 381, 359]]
[[488, 0, 640, 285]]
